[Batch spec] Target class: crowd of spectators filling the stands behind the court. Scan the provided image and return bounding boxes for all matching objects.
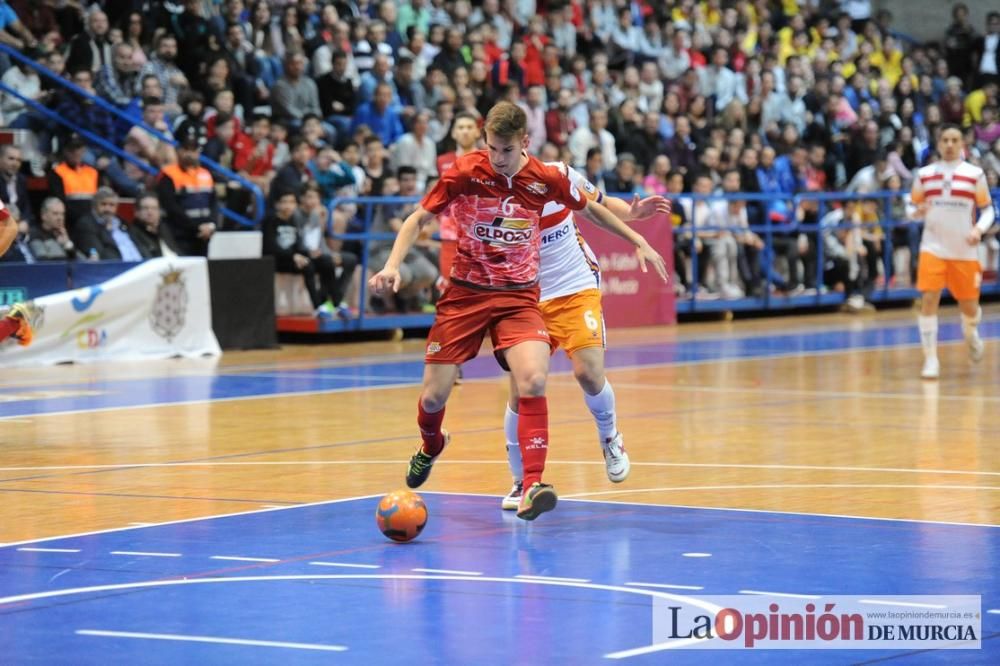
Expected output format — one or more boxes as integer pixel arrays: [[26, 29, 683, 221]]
[[0, 0, 1000, 311]]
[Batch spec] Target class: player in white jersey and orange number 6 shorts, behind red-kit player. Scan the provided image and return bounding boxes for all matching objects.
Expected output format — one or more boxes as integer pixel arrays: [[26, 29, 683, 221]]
[[501, 165, 670, 510]]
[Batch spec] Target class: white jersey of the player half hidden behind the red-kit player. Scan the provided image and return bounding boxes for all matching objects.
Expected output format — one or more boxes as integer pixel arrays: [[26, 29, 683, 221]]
[[538, 162, 604, 301]]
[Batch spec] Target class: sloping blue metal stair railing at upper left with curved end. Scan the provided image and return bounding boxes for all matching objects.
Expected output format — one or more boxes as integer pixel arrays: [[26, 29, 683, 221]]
[[0, 44, 267, 226]]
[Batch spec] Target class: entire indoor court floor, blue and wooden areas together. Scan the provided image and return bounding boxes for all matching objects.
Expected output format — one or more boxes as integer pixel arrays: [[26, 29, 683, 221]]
[[0, 306, 1000, 665]]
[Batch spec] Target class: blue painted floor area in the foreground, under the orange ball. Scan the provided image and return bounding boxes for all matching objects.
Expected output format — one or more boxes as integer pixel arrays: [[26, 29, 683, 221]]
[[0, 493, 1000, 666]]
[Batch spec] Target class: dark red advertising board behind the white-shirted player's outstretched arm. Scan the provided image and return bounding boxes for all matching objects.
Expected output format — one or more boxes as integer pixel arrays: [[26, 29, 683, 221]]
[[577, 215, 677, 328]]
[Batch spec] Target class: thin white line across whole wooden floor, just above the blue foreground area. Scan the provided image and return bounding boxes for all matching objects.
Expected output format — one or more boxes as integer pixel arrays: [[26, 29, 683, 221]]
[[0, 460, 1000, 474]]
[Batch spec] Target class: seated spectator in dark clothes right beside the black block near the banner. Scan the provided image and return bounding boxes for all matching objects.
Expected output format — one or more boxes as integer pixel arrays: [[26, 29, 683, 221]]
[[263, 190, 348, 317]]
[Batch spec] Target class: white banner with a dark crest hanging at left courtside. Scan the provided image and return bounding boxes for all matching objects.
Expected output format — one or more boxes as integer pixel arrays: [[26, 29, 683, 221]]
[[0, 257, 222, 367]]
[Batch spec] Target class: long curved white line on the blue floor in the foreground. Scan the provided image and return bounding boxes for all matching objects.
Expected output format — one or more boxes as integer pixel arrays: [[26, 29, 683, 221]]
[[0, 574, 722, 659]]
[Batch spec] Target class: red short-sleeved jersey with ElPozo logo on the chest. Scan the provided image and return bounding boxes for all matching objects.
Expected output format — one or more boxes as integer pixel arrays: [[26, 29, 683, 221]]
[[420, 150, 587, 289]]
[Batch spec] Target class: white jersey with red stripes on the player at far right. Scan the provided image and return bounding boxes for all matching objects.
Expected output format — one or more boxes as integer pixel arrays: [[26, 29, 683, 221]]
[[912, 160, 992, 261]]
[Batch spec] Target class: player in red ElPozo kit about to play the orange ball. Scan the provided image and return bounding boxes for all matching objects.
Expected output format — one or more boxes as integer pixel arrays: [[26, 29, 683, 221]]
[[371, 102, 655, 520]]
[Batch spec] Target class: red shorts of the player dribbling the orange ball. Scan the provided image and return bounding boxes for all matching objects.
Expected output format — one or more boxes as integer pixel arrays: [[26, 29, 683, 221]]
[[424, 282, 549, 365]]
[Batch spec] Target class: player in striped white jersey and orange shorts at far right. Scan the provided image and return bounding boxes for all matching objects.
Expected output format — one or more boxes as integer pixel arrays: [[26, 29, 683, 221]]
[[911, 124, 996, 379]]
